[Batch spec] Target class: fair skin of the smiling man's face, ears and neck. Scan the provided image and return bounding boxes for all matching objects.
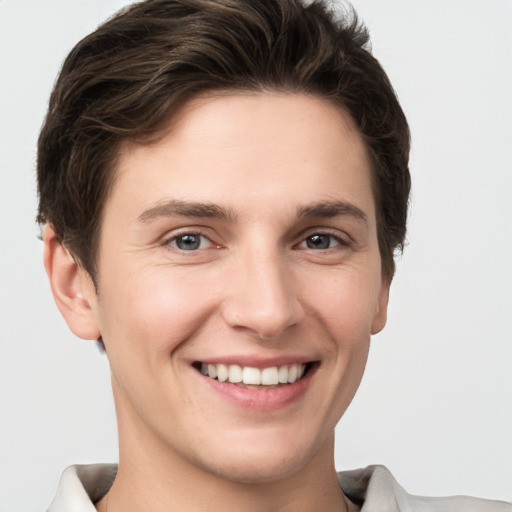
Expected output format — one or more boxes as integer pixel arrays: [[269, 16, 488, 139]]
[[44, 92, 389, 512]]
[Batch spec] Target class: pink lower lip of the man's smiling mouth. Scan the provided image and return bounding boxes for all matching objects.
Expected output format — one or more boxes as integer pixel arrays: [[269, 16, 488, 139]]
[[198, 364, 317, 411]]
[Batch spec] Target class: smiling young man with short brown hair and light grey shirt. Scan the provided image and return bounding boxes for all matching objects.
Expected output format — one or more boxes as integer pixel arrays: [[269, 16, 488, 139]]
[[38, 0, 510, 512]]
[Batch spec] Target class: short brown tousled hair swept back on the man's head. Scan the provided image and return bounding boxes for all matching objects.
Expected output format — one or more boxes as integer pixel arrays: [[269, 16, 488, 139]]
[[37, 0, 410, 280]]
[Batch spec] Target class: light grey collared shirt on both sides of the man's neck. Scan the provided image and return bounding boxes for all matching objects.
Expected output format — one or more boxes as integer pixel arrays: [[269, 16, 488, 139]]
[[47, 464, 512, 512]]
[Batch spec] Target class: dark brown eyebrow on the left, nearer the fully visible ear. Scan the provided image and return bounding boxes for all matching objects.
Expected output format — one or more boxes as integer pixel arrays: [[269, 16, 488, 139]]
[[137, 199, 235, 223]]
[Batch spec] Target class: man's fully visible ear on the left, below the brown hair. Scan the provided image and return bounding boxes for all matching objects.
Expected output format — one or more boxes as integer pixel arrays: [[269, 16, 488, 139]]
[[43, 225, 101, 340]]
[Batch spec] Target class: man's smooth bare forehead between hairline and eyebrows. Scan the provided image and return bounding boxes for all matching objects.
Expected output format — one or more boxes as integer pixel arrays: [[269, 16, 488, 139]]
[[105, 92, 374, 226]]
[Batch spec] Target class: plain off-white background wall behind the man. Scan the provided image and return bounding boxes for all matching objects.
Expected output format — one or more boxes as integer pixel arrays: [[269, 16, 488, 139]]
[[0, 0, 512, 512]]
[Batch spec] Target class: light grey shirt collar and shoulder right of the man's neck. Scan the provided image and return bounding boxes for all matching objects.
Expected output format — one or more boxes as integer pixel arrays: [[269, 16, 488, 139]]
[[338, 466, 512, 512]]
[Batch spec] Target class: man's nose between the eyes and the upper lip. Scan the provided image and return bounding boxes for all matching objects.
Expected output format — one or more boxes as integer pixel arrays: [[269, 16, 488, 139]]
[[222, 244, 305, 340]]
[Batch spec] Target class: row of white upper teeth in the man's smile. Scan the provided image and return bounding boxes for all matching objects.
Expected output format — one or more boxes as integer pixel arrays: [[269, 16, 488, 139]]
[[201, 363, 306, 386]]
